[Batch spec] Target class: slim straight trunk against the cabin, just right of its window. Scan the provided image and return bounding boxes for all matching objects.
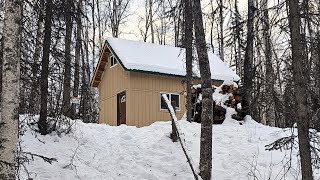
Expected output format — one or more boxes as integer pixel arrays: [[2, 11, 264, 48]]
[[184, 0, 193, 121]]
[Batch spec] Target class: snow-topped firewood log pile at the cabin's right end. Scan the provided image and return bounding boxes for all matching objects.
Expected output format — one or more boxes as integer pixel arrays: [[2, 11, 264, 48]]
[[192, 82, 243, 124]]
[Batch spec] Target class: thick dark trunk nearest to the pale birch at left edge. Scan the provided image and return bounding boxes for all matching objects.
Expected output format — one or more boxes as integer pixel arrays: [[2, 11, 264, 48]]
[[38, 0, 52, 135]]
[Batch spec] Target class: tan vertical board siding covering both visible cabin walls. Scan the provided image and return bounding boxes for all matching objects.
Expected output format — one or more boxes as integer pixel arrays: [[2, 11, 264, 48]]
[[98, 49, 225, 127]]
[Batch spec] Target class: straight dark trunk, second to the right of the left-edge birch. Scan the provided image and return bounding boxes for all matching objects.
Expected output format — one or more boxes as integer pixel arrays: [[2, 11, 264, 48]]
[[62, 1, 72, 117]]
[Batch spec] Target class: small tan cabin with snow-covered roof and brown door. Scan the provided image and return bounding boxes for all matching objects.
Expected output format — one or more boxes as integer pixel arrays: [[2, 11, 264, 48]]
[[91, 38, 240, 127]]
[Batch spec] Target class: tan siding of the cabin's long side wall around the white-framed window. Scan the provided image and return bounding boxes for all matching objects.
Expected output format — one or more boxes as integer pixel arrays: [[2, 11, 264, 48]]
[[128, 72, 186, 127]]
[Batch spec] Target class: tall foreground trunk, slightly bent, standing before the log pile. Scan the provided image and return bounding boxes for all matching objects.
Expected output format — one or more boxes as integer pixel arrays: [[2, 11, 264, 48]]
[[193, 0, 213, 180]]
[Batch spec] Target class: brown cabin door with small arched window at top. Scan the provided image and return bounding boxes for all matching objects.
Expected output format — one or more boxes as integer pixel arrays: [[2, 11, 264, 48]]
[[117, 91, 127, 126]]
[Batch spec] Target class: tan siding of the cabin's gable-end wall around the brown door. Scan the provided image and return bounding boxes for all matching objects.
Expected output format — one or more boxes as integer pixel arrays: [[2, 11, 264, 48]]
[[98, 54, 130, 126]]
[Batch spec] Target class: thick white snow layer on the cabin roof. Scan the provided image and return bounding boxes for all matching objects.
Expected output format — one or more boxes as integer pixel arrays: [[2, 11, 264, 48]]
[[106, 38, 240, 81]]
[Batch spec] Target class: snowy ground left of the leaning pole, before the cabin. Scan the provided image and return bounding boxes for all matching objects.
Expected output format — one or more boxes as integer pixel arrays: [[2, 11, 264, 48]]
[[23, 123, 193, 180]]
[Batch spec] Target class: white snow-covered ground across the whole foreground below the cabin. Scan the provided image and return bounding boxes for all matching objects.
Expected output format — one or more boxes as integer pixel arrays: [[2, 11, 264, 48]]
[[20, 112, 320, 180]]
